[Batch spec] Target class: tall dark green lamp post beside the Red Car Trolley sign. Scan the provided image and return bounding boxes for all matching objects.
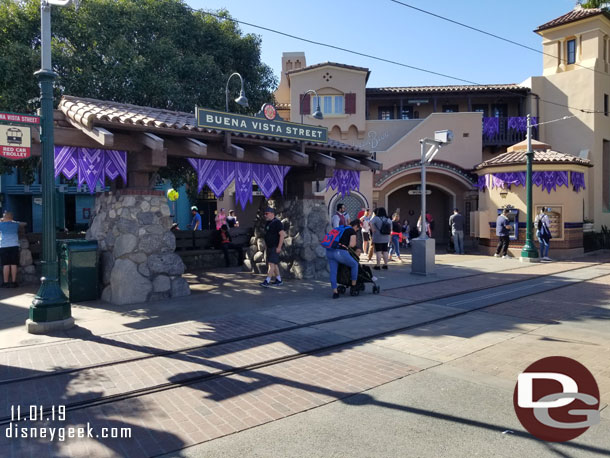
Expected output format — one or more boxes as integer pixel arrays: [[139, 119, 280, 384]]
[[26, 0, 78, 334]]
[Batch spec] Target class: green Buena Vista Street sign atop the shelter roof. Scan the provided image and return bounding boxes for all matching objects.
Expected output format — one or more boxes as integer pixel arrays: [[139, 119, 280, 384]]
[[195, 103, 328, 143]]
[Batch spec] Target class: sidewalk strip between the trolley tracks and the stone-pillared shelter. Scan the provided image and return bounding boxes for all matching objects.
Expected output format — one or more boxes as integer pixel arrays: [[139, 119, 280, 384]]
[[0, 252, 609, 349]]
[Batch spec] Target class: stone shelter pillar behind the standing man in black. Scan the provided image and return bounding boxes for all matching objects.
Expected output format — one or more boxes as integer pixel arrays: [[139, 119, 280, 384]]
[[244, 199, 330, 279]]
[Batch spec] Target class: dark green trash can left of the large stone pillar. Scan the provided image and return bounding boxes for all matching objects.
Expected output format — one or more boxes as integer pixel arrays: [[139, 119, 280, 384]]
[[57, 239, 99, 302]]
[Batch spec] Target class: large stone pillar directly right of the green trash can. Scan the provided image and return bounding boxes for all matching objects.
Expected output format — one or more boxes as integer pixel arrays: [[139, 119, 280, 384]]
[[86, 189, 190, 305]]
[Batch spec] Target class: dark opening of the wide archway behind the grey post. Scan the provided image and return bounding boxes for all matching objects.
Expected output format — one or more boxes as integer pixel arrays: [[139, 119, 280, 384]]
[[387, 183, 455, 243]]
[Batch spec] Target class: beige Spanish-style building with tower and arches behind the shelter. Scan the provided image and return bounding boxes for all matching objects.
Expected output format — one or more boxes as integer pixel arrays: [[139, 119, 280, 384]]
[[275, 6, 610, 253]]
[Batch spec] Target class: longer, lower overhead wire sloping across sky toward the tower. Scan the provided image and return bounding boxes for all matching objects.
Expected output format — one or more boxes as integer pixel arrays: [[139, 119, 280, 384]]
[[201, 10, 604, 114]]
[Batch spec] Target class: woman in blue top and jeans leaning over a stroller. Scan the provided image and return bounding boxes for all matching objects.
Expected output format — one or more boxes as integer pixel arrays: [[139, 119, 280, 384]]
[[322, 219, 360, 299]]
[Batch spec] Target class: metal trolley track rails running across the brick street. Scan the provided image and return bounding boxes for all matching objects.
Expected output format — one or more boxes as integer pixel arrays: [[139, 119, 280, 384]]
[[0, 263, 610, 426]]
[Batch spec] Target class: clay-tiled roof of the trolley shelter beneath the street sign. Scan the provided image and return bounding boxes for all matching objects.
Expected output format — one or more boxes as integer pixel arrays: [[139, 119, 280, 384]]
[[58, 95, 366, 156]]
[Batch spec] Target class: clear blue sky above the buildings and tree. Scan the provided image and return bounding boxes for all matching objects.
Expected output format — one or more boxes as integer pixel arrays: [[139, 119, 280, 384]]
[[186, 0, 576, 87]]
